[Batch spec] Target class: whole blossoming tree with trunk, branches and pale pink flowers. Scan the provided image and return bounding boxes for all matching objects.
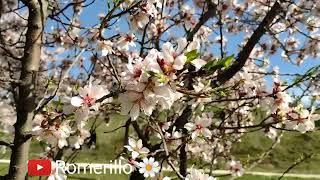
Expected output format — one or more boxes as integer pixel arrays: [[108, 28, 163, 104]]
[[0, 0, 320, 180]]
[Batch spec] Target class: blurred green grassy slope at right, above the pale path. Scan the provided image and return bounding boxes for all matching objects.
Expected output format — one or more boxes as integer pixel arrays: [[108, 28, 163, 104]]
[[234, 132, 320, 174]]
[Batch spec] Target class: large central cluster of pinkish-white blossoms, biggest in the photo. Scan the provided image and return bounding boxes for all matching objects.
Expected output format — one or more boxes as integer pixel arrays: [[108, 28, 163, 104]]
[[119, 38, 205, 120]]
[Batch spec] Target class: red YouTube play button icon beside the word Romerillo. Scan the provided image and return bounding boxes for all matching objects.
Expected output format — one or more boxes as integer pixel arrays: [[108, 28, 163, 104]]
[[28, 159, 51, 176]]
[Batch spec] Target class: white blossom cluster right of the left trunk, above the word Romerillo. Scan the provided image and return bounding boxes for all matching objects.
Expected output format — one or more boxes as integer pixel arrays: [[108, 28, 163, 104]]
[[32, 81, 109, 151]]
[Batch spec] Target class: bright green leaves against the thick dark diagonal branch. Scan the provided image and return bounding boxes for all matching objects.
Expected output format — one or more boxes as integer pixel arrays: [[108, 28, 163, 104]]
[[203, 55, 234, 74]]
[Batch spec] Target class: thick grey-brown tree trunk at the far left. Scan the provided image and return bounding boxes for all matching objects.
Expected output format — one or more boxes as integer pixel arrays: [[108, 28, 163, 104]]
[[7, 0, 48, 180]]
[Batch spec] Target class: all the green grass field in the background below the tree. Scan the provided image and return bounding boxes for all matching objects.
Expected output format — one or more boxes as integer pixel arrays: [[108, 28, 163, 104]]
[[0, 115, 320, 180]]
